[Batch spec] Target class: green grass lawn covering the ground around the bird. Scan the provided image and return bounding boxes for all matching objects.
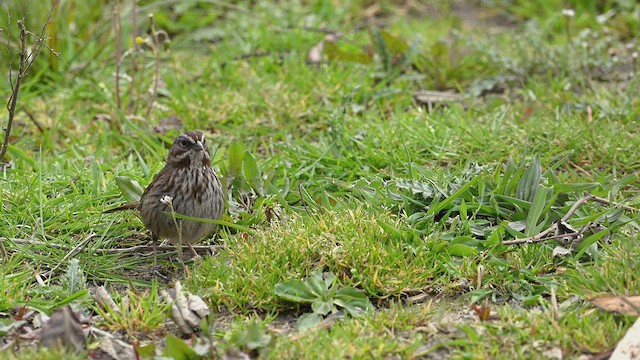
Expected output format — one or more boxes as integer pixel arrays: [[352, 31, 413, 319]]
[[0, 0, 640, 359]]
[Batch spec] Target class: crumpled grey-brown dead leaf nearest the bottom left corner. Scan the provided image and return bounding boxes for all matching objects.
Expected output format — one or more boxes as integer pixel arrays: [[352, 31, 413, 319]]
[[40, 306, 86, 353]]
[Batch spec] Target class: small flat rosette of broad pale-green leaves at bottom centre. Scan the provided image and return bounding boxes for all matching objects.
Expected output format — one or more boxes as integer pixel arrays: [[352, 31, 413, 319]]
[[275, 270, 375, 331]]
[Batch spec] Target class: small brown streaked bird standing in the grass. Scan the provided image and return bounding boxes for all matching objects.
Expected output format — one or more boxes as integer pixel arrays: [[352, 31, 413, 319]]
[[107, 131, 224, 271]]
